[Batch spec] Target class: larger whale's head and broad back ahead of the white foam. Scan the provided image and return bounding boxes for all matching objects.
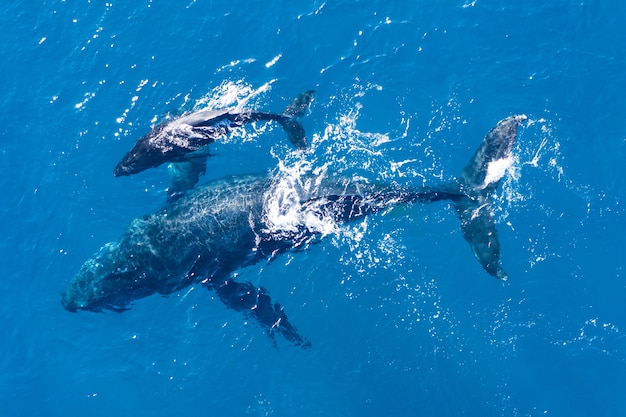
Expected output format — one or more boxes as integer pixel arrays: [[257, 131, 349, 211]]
[[62, 176, 268, 311]]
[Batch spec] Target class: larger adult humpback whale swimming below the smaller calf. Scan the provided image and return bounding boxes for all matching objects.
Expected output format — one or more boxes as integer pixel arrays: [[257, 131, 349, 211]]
[[61, 115, 526, 347]]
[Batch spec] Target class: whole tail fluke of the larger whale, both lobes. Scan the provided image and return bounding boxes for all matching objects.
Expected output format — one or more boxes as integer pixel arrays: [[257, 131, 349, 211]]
[[453, 115, 526, 280]]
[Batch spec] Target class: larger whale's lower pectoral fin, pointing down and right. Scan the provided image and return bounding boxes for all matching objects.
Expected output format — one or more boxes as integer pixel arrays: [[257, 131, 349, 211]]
[[205, 279, 311, 348]]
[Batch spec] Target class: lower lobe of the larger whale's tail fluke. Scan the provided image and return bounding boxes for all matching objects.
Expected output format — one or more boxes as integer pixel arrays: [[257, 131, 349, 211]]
[[455, 199, 507, 281]]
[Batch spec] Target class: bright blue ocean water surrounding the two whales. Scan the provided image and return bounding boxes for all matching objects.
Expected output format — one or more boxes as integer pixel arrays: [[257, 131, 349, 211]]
[[0, 0, 626, 416]]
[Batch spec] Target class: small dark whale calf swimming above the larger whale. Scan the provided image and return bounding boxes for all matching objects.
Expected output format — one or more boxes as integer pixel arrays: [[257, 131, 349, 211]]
[[113, 90, 315, 177]]
